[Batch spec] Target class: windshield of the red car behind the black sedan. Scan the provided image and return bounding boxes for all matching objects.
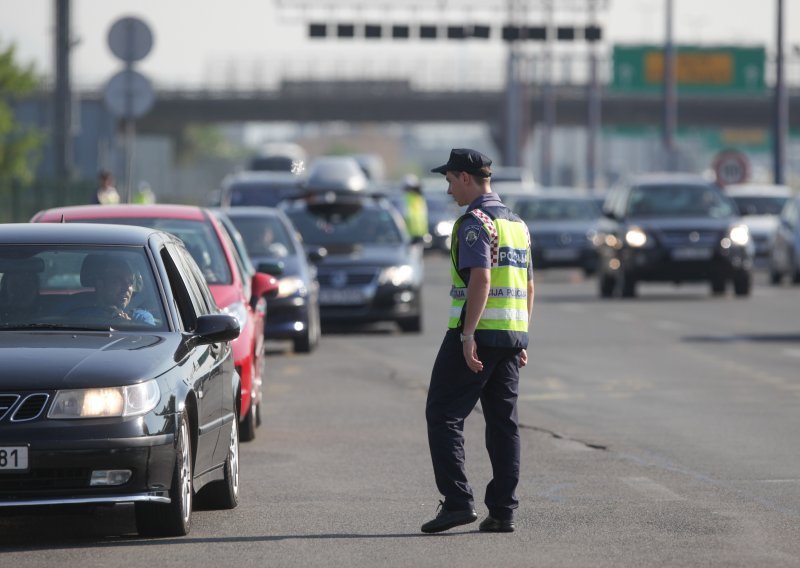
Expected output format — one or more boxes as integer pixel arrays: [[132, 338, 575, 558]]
[[76, 217, 233, 284]]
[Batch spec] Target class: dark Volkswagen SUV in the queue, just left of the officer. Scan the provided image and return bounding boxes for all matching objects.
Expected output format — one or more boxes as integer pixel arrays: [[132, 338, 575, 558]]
[[282, 191, 423, 332]]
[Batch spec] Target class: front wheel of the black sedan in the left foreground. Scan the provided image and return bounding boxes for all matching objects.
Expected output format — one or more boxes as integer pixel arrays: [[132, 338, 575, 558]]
[[135, 412, 193, 536]]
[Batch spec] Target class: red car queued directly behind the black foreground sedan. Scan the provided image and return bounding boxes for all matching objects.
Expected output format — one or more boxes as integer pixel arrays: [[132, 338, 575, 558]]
[[31, 204, 278, 441]]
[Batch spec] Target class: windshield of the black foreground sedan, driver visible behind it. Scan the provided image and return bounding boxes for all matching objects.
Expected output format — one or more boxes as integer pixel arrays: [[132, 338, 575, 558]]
[[0, 245, 168, 332]]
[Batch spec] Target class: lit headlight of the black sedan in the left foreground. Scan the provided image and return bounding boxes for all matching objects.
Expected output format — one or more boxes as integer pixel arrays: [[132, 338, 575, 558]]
[[47, 380, 161, 420]]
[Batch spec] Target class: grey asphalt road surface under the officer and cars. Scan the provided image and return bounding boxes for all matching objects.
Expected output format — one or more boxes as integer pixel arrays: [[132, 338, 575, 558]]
[[0, 256, 800, 568]]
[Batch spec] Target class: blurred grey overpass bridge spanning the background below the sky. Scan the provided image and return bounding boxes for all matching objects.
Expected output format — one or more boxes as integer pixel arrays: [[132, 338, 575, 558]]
[[122, 80, 800, 134]]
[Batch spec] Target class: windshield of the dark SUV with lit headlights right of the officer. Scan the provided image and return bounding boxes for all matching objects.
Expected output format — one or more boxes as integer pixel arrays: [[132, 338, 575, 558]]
[[628, 184, 736, 218]]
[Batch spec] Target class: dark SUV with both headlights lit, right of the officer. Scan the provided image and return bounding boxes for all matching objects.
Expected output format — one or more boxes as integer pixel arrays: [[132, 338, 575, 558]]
[[595, 174, 754, 298]]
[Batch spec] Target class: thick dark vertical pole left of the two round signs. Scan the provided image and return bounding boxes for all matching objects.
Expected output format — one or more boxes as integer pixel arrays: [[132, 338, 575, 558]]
[[52, 0, 72, 191]]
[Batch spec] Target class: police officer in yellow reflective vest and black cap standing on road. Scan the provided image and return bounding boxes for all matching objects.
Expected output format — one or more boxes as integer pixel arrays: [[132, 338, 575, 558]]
[[422, 148, 533, 533]]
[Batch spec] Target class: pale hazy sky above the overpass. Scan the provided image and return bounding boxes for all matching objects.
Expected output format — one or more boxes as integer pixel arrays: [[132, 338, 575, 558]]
[[0, 0, 800, 88]]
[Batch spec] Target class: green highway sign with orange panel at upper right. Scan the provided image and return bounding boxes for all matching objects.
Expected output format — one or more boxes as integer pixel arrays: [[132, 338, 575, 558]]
[[611, 45, 766, 95]]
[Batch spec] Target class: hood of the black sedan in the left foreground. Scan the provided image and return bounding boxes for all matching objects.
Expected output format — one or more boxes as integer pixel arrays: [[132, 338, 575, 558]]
[[0, 331, 181, 390]]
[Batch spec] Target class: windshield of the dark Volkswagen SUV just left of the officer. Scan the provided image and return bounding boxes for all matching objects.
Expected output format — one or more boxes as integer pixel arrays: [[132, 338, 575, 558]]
[[286, 205, 403, 245]]
